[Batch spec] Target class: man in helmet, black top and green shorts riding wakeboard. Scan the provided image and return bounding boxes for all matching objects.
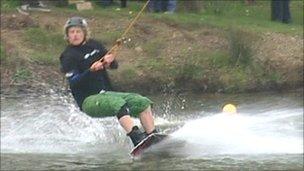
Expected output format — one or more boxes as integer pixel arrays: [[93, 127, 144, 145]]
[[60, 17, 157, 146]]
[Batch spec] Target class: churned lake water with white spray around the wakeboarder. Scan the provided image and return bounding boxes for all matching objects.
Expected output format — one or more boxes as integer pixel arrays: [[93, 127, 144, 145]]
[[1, 90, 303, 170]]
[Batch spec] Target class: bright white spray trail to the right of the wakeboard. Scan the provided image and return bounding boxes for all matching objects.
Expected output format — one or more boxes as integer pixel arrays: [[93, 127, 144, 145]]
[[172, 109, 303, 156]]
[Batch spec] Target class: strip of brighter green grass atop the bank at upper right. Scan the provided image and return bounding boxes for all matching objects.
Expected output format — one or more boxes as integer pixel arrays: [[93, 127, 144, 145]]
[[151, 1, 303, 35]]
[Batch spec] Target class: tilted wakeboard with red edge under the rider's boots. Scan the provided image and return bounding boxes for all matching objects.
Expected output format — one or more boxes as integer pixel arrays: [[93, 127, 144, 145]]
[[130, 133, 168, 157]]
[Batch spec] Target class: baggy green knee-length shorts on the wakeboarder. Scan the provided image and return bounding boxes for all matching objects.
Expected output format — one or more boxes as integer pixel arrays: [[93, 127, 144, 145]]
[[82, 91, 153, 117]]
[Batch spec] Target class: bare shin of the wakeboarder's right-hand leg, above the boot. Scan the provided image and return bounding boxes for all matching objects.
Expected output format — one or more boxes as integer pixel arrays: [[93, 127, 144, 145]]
[[139, 106, 155, 134]]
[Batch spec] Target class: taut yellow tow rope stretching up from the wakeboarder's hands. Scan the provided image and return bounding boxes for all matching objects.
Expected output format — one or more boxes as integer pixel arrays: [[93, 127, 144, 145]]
[[99, 0, 150, 62]]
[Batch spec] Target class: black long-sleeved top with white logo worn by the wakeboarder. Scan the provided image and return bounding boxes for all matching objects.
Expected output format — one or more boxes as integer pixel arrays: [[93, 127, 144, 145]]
[[60, 39, 118, 109]]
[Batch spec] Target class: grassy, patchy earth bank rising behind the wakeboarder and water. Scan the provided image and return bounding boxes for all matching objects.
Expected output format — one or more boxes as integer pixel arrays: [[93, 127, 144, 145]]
[[1, 0, 303, 92]]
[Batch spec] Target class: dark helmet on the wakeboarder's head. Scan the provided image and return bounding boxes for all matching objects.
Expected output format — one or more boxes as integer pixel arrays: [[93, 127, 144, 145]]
[[64, 16, 89, 39]]
